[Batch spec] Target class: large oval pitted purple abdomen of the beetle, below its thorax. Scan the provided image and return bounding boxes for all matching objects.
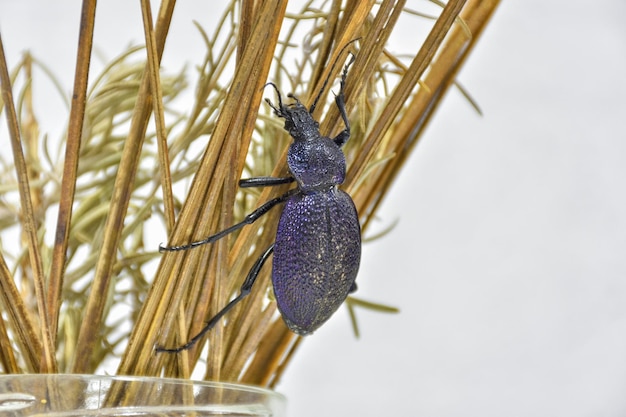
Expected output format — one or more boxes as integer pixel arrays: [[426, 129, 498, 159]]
[[272, 188, 361, 335]]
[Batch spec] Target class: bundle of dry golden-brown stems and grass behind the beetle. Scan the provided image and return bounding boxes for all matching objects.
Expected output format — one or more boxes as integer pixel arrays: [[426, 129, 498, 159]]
[[0, 0, 497, 386]]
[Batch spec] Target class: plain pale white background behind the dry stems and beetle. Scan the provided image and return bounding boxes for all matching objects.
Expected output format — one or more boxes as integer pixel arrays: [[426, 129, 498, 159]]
[[0, 0, 626, 417]]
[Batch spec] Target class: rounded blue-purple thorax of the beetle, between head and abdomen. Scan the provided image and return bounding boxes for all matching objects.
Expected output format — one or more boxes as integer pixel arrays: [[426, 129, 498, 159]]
[[287, 139, 346, 192]]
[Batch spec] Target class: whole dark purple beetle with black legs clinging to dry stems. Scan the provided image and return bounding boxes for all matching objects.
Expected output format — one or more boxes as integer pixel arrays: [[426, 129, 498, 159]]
[[156, 45, 361, 353]]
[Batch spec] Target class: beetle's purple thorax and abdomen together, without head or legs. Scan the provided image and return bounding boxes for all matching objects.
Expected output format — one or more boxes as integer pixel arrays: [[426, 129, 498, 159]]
[[272, 133, 361, 335]]
